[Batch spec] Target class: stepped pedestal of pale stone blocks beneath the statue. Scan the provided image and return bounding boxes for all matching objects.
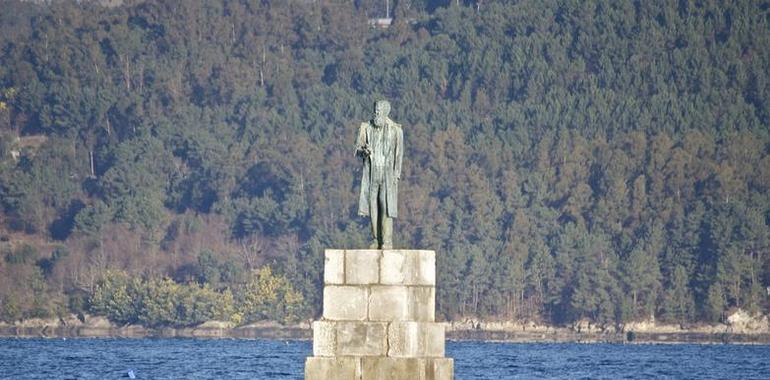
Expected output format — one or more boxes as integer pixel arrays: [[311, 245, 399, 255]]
[[305, 249, 454, 380]]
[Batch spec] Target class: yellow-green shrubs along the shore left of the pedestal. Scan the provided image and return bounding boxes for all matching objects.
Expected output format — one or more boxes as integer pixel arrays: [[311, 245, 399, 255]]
[[89, 267, 303, 327]]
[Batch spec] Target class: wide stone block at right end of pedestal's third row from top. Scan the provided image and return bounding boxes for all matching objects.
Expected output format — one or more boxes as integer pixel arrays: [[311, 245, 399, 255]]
[[388, 321, 445, 358]]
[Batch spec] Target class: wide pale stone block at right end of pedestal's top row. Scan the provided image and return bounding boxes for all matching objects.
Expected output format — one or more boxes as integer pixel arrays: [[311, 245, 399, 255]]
[[380, 250, 436, 286]]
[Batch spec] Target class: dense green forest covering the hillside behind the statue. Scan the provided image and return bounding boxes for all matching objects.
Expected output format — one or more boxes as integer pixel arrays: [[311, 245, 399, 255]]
[[0, 0, 770, 326]]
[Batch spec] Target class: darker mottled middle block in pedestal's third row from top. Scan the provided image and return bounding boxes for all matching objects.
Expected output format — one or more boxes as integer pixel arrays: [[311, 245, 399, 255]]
[[337, 322, 388, 356]]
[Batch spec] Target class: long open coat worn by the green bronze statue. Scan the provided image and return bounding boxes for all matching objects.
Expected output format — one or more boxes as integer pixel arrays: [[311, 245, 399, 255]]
[[356, 119, 404, 218]]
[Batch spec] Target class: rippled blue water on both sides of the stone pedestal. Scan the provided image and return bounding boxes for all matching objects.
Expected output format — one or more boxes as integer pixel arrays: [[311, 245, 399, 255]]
[[0, 338, 770, 380]]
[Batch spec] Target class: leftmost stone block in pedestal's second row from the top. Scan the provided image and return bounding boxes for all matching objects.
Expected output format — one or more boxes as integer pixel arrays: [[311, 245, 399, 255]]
[[323, 285, 369, 321]]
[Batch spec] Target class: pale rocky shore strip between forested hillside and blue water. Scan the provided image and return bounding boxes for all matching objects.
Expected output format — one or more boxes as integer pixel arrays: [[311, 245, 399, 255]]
[[0, 310, 770, 344]]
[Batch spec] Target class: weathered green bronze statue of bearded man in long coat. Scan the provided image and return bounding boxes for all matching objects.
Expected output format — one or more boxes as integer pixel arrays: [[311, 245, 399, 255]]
[[356, 100, 404, 249]]
